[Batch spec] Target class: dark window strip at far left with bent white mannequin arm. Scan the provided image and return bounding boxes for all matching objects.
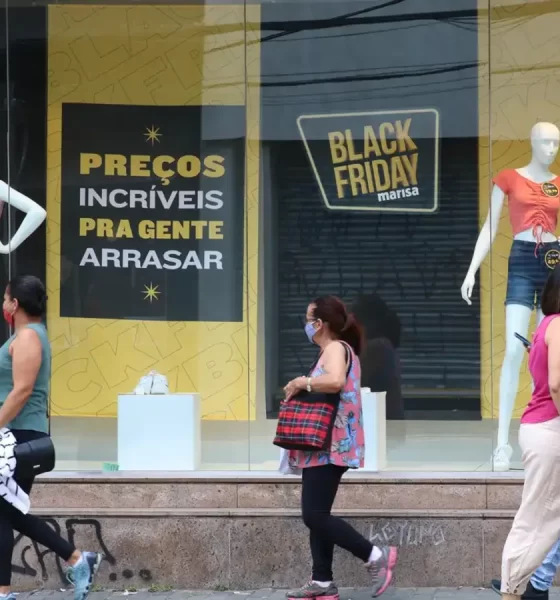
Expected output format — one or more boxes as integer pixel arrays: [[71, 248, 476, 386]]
[[0, 7, 47, 404]]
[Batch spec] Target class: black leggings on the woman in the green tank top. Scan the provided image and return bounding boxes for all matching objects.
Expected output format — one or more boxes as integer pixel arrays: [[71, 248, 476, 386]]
[[0, 429, 75, 586]]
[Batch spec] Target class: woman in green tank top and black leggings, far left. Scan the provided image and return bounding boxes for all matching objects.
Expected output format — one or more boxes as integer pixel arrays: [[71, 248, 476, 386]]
[[0, 275, 102, 600]]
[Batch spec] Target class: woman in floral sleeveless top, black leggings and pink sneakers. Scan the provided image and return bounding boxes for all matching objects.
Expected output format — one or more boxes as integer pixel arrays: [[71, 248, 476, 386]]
[[284, 296, 397, 600]]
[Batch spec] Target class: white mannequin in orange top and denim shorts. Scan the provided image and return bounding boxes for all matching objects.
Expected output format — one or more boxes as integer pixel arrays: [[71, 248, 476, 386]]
[[461, 122, 560, 471]]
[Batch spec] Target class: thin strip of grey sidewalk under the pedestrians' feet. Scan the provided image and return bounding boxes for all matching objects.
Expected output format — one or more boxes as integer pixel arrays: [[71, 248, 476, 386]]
[[9, 588, 560, 600]]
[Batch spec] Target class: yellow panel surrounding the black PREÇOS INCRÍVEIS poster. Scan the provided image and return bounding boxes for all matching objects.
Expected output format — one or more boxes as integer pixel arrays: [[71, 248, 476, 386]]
[[47, 5, 260, 420]]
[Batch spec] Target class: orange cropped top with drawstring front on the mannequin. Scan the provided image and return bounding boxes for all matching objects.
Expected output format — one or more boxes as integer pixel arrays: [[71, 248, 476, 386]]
[[493, 169, 560, 242]]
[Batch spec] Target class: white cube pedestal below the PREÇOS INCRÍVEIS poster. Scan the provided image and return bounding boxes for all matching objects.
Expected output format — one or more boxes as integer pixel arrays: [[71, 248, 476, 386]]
[[118, 394, 200, 471]]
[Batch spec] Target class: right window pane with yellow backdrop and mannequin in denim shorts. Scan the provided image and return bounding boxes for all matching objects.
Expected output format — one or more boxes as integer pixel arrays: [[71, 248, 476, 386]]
[[481, 0, 560, 469]]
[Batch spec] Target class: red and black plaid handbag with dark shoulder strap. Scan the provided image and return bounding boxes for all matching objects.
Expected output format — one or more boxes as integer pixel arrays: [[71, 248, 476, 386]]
[[273, 345, 352, 451]]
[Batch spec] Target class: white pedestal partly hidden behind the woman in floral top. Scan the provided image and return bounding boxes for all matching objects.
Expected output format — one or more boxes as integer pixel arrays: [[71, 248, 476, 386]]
[[362, 388, 387, 471]]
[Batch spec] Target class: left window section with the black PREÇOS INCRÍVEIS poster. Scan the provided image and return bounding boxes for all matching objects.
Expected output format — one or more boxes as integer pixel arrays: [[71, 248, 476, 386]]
[[3, 3, 259, 470]]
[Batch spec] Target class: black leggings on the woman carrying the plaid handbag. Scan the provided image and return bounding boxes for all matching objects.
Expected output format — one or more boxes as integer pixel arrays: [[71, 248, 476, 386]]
[[301, 465, 373, 581]]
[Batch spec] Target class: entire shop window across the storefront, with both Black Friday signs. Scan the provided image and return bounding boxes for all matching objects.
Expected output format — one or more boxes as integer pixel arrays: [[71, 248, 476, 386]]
[[7, 0, 560, 471]]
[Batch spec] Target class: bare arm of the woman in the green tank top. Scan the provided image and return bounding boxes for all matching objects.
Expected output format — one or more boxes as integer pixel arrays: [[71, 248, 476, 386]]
[[0, 328, 42, 428]]
